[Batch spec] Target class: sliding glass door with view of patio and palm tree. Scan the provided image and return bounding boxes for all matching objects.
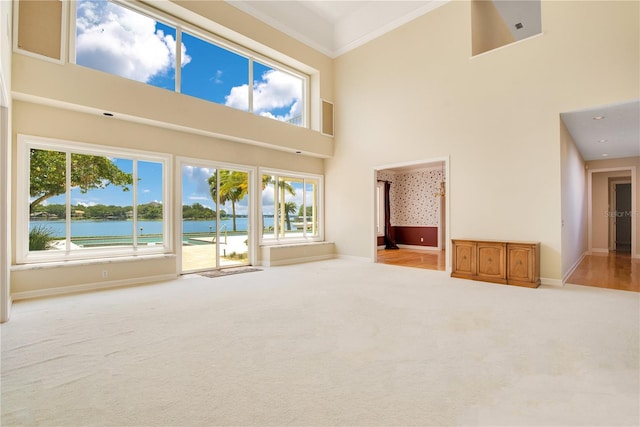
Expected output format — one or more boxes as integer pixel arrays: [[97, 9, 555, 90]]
[[180, 161, 253, 274]]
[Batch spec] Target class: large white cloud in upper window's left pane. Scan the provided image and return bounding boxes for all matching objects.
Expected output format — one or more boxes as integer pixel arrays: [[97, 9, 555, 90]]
[[76, 1, 191, 82]]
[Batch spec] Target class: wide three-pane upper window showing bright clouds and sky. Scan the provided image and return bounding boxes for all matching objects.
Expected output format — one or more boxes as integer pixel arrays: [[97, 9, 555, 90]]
[[75, 0, 308, 126]]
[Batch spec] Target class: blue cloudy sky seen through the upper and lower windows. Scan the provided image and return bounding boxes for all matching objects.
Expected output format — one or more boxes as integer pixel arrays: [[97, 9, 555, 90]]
[[53, 0, 303, 214]]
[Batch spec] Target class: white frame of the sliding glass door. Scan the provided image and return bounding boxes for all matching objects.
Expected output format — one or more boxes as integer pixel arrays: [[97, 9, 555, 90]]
[[174, 156, 261, 274]]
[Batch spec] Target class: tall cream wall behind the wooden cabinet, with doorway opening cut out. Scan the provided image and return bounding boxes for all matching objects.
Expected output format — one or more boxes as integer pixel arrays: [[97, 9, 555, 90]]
[[326, 1, 640, 283]]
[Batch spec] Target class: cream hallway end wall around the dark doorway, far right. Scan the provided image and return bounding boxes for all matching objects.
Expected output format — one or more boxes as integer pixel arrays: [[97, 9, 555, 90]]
[[587, 157, 640, 258]]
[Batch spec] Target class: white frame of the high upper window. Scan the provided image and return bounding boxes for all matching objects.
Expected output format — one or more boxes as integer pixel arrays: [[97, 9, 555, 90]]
[[69, 0, 311, 129]]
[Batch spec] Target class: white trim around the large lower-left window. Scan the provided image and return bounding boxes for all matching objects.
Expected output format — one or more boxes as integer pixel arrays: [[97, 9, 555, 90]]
[[16, 134, 173, 264]]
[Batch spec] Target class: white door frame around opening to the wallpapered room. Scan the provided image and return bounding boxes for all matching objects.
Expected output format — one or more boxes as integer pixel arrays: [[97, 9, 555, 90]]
[[369, 156, 451, 273]]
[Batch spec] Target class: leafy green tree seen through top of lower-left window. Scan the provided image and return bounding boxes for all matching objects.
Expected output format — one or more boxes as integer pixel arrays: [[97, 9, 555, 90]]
[[29, 149, 133, 212]]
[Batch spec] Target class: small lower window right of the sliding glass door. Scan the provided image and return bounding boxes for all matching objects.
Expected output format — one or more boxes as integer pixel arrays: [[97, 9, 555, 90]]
[[261, 171, 323, 243]]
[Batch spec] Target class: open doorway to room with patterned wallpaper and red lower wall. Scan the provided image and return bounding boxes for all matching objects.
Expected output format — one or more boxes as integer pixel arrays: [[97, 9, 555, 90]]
[[373, 158, 450, 270]]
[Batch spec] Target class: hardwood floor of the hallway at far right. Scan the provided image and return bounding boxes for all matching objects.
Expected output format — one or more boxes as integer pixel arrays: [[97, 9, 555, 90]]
[[567, 252, 640, 292]]
